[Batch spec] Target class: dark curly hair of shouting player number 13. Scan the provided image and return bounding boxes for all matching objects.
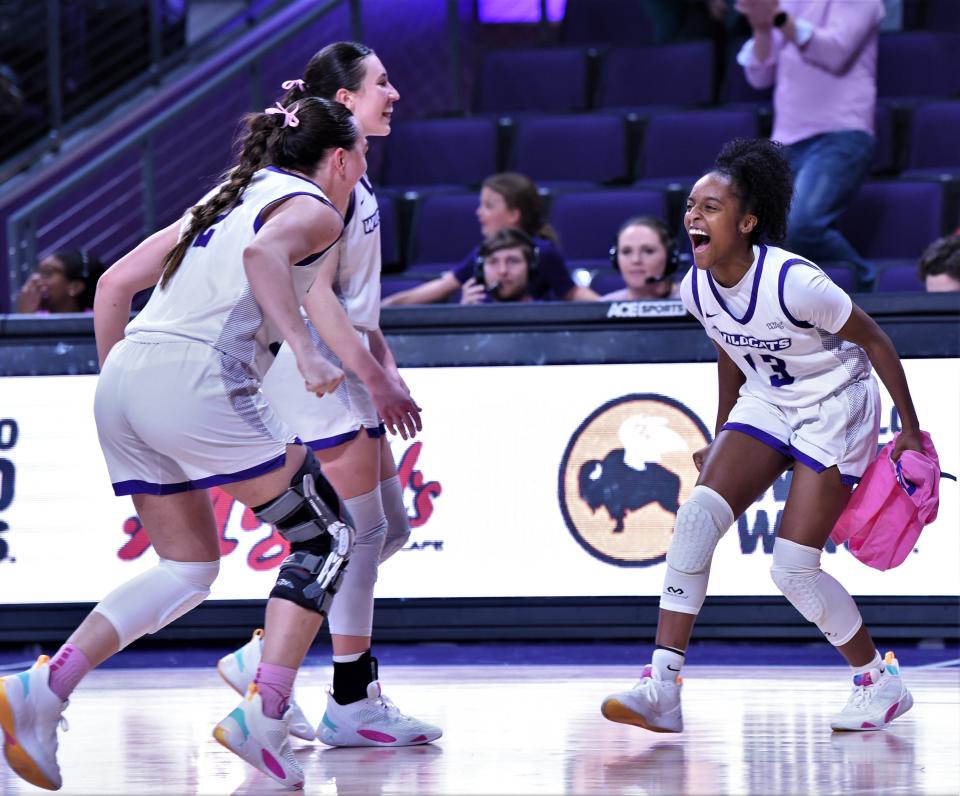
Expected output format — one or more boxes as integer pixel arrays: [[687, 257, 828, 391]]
[[713, 138, 793, 244]]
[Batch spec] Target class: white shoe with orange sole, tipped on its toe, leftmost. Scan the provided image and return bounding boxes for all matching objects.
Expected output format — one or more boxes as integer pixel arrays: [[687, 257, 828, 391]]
[[0, 655, 69, 790]]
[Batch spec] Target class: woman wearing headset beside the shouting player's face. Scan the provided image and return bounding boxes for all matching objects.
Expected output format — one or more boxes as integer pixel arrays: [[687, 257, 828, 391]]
[[601, 216, 680, 301]]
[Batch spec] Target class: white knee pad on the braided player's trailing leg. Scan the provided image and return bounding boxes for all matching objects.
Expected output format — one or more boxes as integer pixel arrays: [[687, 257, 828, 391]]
[[93, 558, 220, 649]]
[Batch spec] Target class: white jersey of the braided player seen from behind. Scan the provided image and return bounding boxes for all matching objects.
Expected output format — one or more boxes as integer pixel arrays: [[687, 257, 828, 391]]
[[126, 166, 333, 378]]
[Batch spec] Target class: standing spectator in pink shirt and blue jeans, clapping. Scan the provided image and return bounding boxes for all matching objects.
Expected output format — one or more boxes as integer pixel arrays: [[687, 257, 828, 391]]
[[736, 0, 884, 289]]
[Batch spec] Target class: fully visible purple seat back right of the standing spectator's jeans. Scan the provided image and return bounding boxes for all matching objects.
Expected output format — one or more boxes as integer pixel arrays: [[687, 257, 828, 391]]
[[838, 180, 943, 260]]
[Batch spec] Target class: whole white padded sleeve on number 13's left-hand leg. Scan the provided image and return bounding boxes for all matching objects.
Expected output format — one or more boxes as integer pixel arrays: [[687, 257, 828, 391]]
[[660, 485, 733, 614]]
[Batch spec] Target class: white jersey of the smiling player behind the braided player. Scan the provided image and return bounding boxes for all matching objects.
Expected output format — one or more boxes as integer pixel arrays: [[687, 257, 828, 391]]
[[333, 177, 380, 331]]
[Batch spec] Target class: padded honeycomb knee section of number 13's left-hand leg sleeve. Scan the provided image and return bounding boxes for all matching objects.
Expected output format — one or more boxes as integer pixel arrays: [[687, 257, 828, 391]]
[[667, 485, 733, 575]]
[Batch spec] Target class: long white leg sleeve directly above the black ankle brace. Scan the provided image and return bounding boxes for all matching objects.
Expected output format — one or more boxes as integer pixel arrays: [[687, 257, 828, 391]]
[[327, 487, 387, 636]]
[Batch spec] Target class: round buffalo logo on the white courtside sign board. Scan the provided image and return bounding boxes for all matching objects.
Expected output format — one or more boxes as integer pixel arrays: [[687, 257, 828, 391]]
[[558, 394, 710, 567]]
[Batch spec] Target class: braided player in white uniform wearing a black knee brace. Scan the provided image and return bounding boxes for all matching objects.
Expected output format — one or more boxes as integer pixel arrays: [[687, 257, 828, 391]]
[[0, 97, 366, 790]]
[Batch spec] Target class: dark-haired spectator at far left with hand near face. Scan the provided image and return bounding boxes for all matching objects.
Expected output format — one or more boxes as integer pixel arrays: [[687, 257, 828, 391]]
[[14, 249, 103, 313]]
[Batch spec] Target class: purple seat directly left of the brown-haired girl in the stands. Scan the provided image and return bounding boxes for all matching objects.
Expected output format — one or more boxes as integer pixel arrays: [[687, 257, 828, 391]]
[[407, 193, 481, 267]]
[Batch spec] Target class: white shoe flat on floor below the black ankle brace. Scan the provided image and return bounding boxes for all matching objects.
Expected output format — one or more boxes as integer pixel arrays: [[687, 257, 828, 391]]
[[317, 680, 443, 746]]
